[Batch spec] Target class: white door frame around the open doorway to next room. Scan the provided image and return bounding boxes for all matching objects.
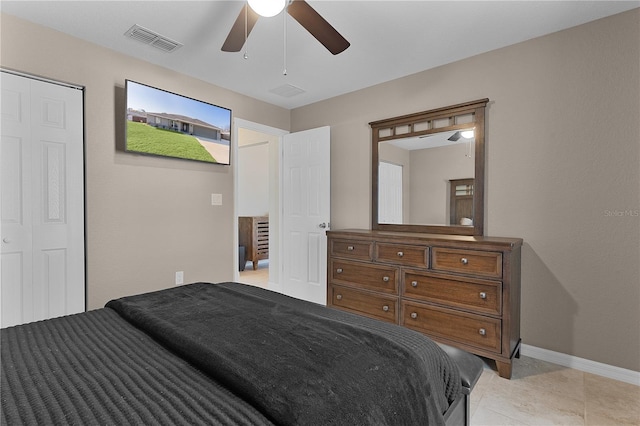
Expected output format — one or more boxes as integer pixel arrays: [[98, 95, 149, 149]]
[[231, 117, 290, 292]]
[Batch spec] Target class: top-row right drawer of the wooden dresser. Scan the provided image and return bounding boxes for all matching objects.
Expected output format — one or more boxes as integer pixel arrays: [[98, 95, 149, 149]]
[[431, 247, 502, 278]]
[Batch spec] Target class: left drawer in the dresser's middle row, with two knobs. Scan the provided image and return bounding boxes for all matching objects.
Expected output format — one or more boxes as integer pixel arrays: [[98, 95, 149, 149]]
[[330, 259, 400, 294]]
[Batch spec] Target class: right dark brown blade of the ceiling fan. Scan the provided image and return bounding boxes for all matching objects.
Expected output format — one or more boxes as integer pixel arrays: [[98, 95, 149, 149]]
[[287, 0, 351, 55]]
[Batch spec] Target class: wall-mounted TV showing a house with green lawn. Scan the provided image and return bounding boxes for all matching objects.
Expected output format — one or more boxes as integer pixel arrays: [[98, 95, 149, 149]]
[[125, 80, 231, 165]]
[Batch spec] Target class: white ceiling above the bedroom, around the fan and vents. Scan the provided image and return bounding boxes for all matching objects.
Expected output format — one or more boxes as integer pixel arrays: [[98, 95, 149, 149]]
[[0, 0, 640, 109]]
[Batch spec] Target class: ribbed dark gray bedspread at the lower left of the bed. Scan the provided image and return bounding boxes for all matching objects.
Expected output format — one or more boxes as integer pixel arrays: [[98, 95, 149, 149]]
[[0, 309, 270, 426]]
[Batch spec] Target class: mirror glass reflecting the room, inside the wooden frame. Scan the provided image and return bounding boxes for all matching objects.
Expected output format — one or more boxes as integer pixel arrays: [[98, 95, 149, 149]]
[[378, 129, 475, 226]]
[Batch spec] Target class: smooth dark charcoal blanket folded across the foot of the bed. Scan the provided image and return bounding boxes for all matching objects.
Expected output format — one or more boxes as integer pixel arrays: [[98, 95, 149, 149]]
[[107, 283, 460, 425]]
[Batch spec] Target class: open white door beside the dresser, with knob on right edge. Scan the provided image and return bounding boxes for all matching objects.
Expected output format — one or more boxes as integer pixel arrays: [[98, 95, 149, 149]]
[[282, 127, 331, 304]]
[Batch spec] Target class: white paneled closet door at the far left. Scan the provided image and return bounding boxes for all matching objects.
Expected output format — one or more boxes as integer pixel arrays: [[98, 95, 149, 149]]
[[0, 71, 85, 327]]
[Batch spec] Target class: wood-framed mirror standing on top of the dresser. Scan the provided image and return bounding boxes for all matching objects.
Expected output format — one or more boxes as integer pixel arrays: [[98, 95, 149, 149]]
[[369, 99, 488, 236]]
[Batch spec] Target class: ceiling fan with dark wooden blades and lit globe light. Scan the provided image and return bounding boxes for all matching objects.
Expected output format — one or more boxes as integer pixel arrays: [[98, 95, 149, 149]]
[[222, 0, 351, 55]]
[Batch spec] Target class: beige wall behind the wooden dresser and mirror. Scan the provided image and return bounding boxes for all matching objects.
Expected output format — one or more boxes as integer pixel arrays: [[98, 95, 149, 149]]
[[291, 9, 640, 371]]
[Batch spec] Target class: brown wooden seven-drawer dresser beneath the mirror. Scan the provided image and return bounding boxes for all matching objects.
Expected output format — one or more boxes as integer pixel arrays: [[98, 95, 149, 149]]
[[327, 230, 522, 378]]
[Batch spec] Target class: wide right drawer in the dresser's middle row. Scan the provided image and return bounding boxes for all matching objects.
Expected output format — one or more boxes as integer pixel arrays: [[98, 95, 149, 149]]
[[402, 270, 502, 316]]
